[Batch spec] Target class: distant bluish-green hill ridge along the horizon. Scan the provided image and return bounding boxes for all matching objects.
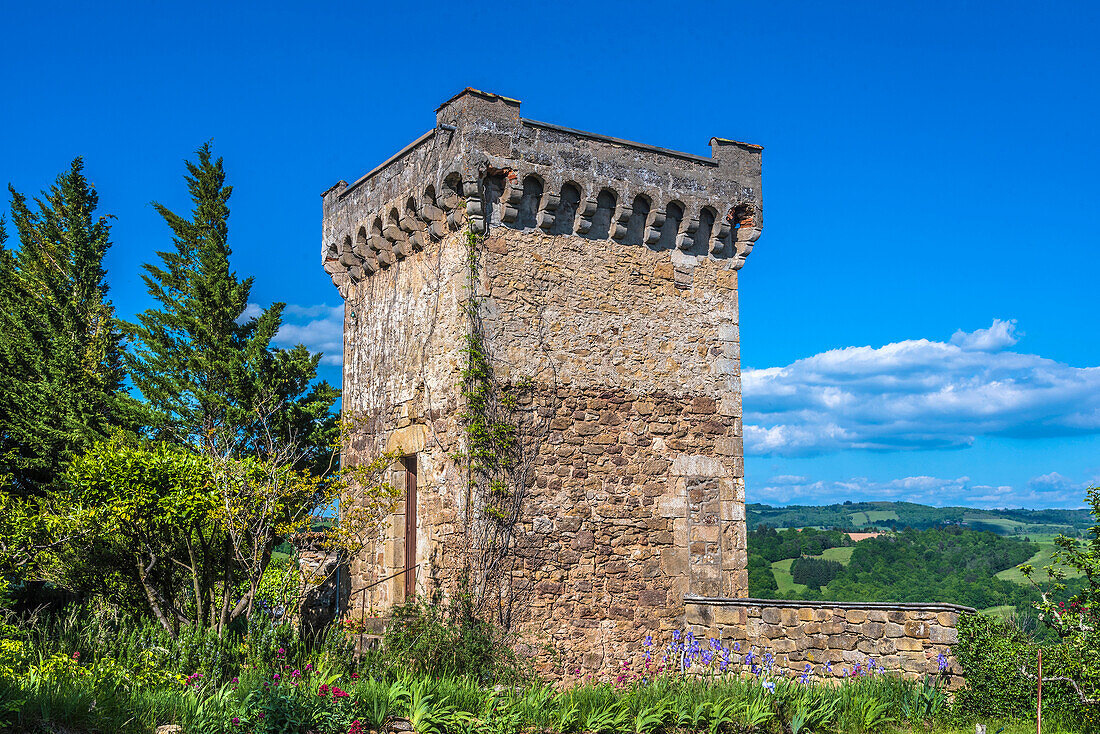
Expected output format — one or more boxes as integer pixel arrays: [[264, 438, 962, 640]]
[[745, 502, 1093, 536]]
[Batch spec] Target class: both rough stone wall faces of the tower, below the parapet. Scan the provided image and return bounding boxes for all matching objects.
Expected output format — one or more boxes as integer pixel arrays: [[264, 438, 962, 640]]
[[336, 227, 747, 670]]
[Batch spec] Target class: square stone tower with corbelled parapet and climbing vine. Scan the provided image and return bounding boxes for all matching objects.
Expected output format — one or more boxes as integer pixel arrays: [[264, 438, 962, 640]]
[[322, 89, 761, 671]]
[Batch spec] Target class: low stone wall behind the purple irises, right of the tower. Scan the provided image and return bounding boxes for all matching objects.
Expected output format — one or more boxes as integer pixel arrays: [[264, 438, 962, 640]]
[[684, 596, 977, 678]]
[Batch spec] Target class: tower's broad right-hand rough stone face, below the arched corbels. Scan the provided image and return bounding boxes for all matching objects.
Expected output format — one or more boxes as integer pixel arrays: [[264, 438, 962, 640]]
[[480, 228, 747, 670]]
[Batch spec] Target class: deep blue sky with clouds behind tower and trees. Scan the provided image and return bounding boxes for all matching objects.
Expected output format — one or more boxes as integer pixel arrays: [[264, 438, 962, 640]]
[[0, 1, 1100, 507]]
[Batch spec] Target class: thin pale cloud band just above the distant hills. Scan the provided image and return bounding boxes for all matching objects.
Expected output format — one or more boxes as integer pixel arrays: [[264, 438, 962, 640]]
[[746, 472, 1087, 508]]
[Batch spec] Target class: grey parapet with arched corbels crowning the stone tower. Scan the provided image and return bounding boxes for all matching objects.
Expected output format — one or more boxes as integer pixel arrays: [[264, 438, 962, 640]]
[[322, 89, 762, 295]]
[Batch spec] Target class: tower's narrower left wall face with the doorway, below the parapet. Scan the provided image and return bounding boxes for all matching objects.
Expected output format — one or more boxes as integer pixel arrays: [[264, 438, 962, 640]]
[[343, 235, 466, 617]]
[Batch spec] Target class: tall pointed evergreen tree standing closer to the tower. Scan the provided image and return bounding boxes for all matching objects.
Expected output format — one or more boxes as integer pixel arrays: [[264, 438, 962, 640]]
[[130, 143, 339, 468]]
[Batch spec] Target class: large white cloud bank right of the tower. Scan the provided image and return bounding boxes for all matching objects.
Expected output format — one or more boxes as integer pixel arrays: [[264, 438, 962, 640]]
[[741, 320, 1100, 456]]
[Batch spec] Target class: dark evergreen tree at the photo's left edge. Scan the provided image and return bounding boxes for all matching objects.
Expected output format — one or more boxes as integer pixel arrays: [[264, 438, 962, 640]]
[[0, 157, 138, 495]]
